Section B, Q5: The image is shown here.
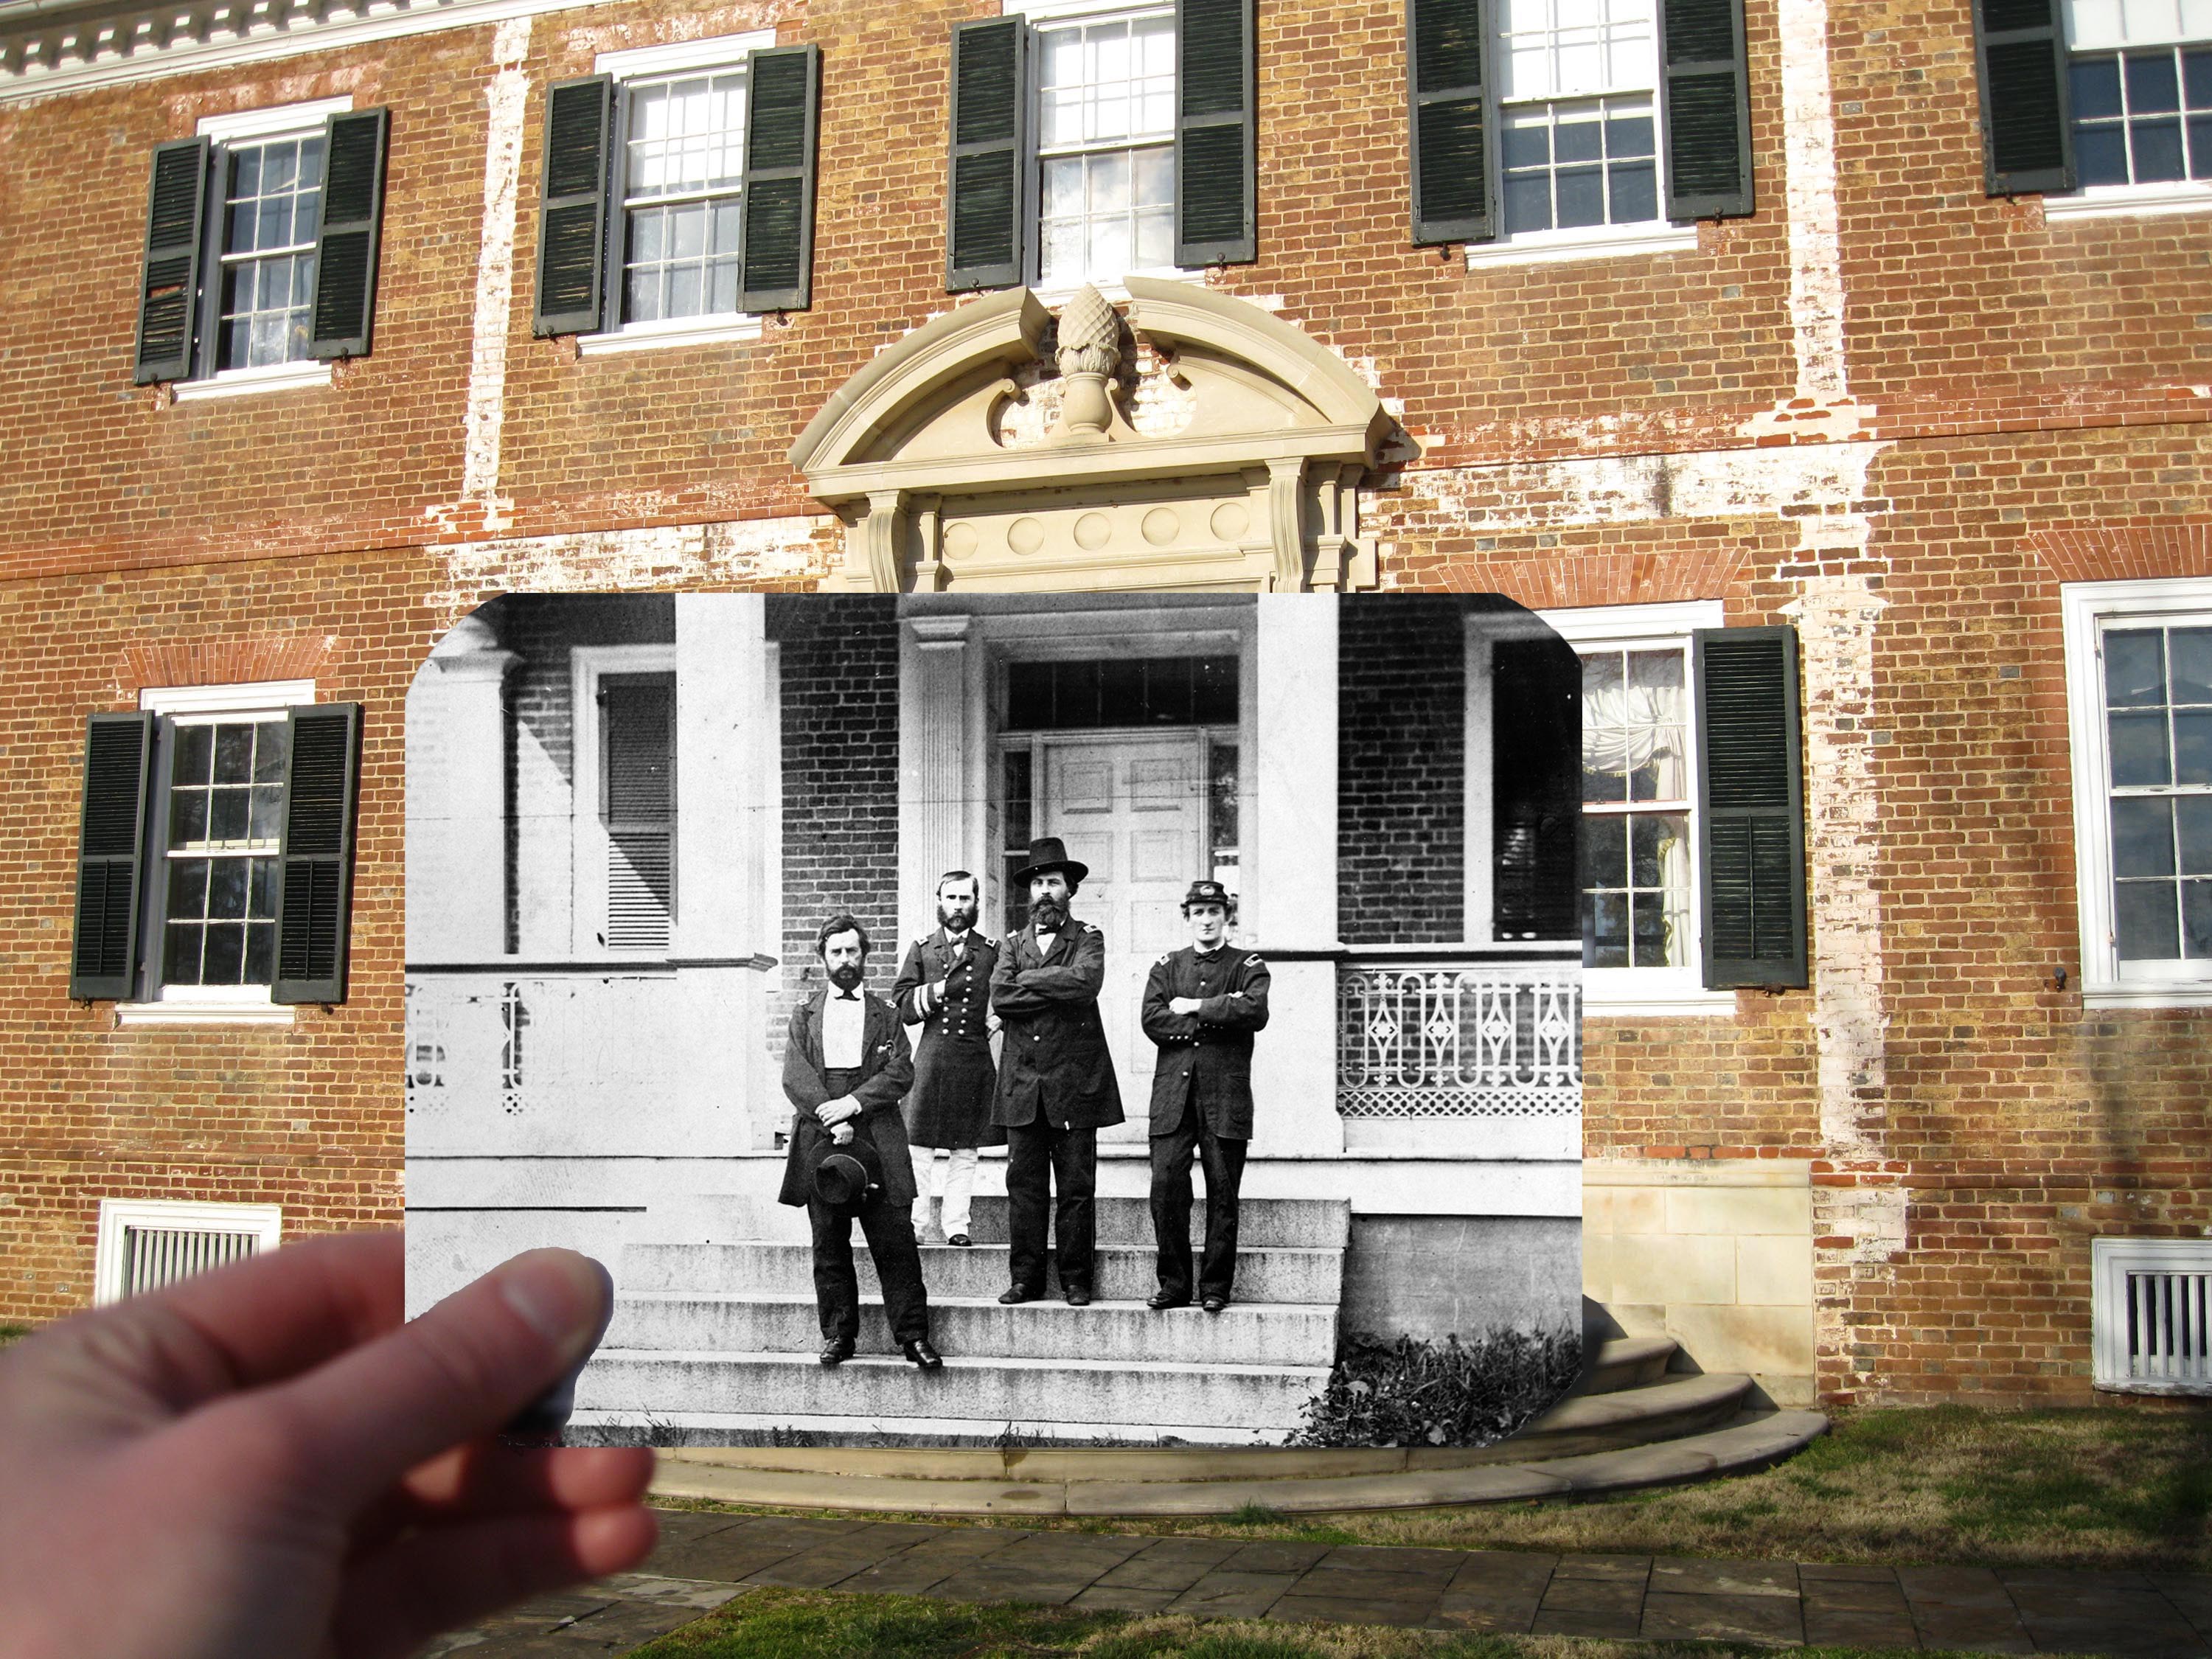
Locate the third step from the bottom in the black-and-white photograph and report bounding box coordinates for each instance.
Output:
[617,1239,1345,1307]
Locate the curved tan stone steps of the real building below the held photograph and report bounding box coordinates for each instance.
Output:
[653,1336,1827,1517]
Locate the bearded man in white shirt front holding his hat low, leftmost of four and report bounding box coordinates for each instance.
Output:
[776,914,945,1371]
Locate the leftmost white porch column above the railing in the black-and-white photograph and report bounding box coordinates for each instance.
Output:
[407,617,522,962]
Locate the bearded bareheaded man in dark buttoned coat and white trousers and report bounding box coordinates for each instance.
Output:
[891,869,1006,1245]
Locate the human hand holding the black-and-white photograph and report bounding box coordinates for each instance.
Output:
[0,1232,655,1659]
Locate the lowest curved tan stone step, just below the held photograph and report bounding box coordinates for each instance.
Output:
[653,1411,1827,1517]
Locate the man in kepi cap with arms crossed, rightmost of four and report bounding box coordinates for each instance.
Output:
[1144,880,1267,1314]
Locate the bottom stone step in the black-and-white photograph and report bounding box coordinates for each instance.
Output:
[575,1345,1329,1444]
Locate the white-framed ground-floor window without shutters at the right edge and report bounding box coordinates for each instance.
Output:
[2059,577,2212,1006]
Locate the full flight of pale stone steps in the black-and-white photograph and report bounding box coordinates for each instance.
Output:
[577,1197,1352,1447]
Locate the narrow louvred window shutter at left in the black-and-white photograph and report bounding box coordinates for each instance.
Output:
[599,675,677,951]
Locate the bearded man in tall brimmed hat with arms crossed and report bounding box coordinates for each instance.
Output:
[991,836,1121,1307]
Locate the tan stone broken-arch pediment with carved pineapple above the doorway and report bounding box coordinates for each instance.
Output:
[792,276,1391,593]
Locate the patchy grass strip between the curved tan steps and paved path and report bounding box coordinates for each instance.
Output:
[655,1407,2212,1573]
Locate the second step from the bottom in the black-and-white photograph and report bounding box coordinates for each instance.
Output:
[606,1290,1336,1367]
